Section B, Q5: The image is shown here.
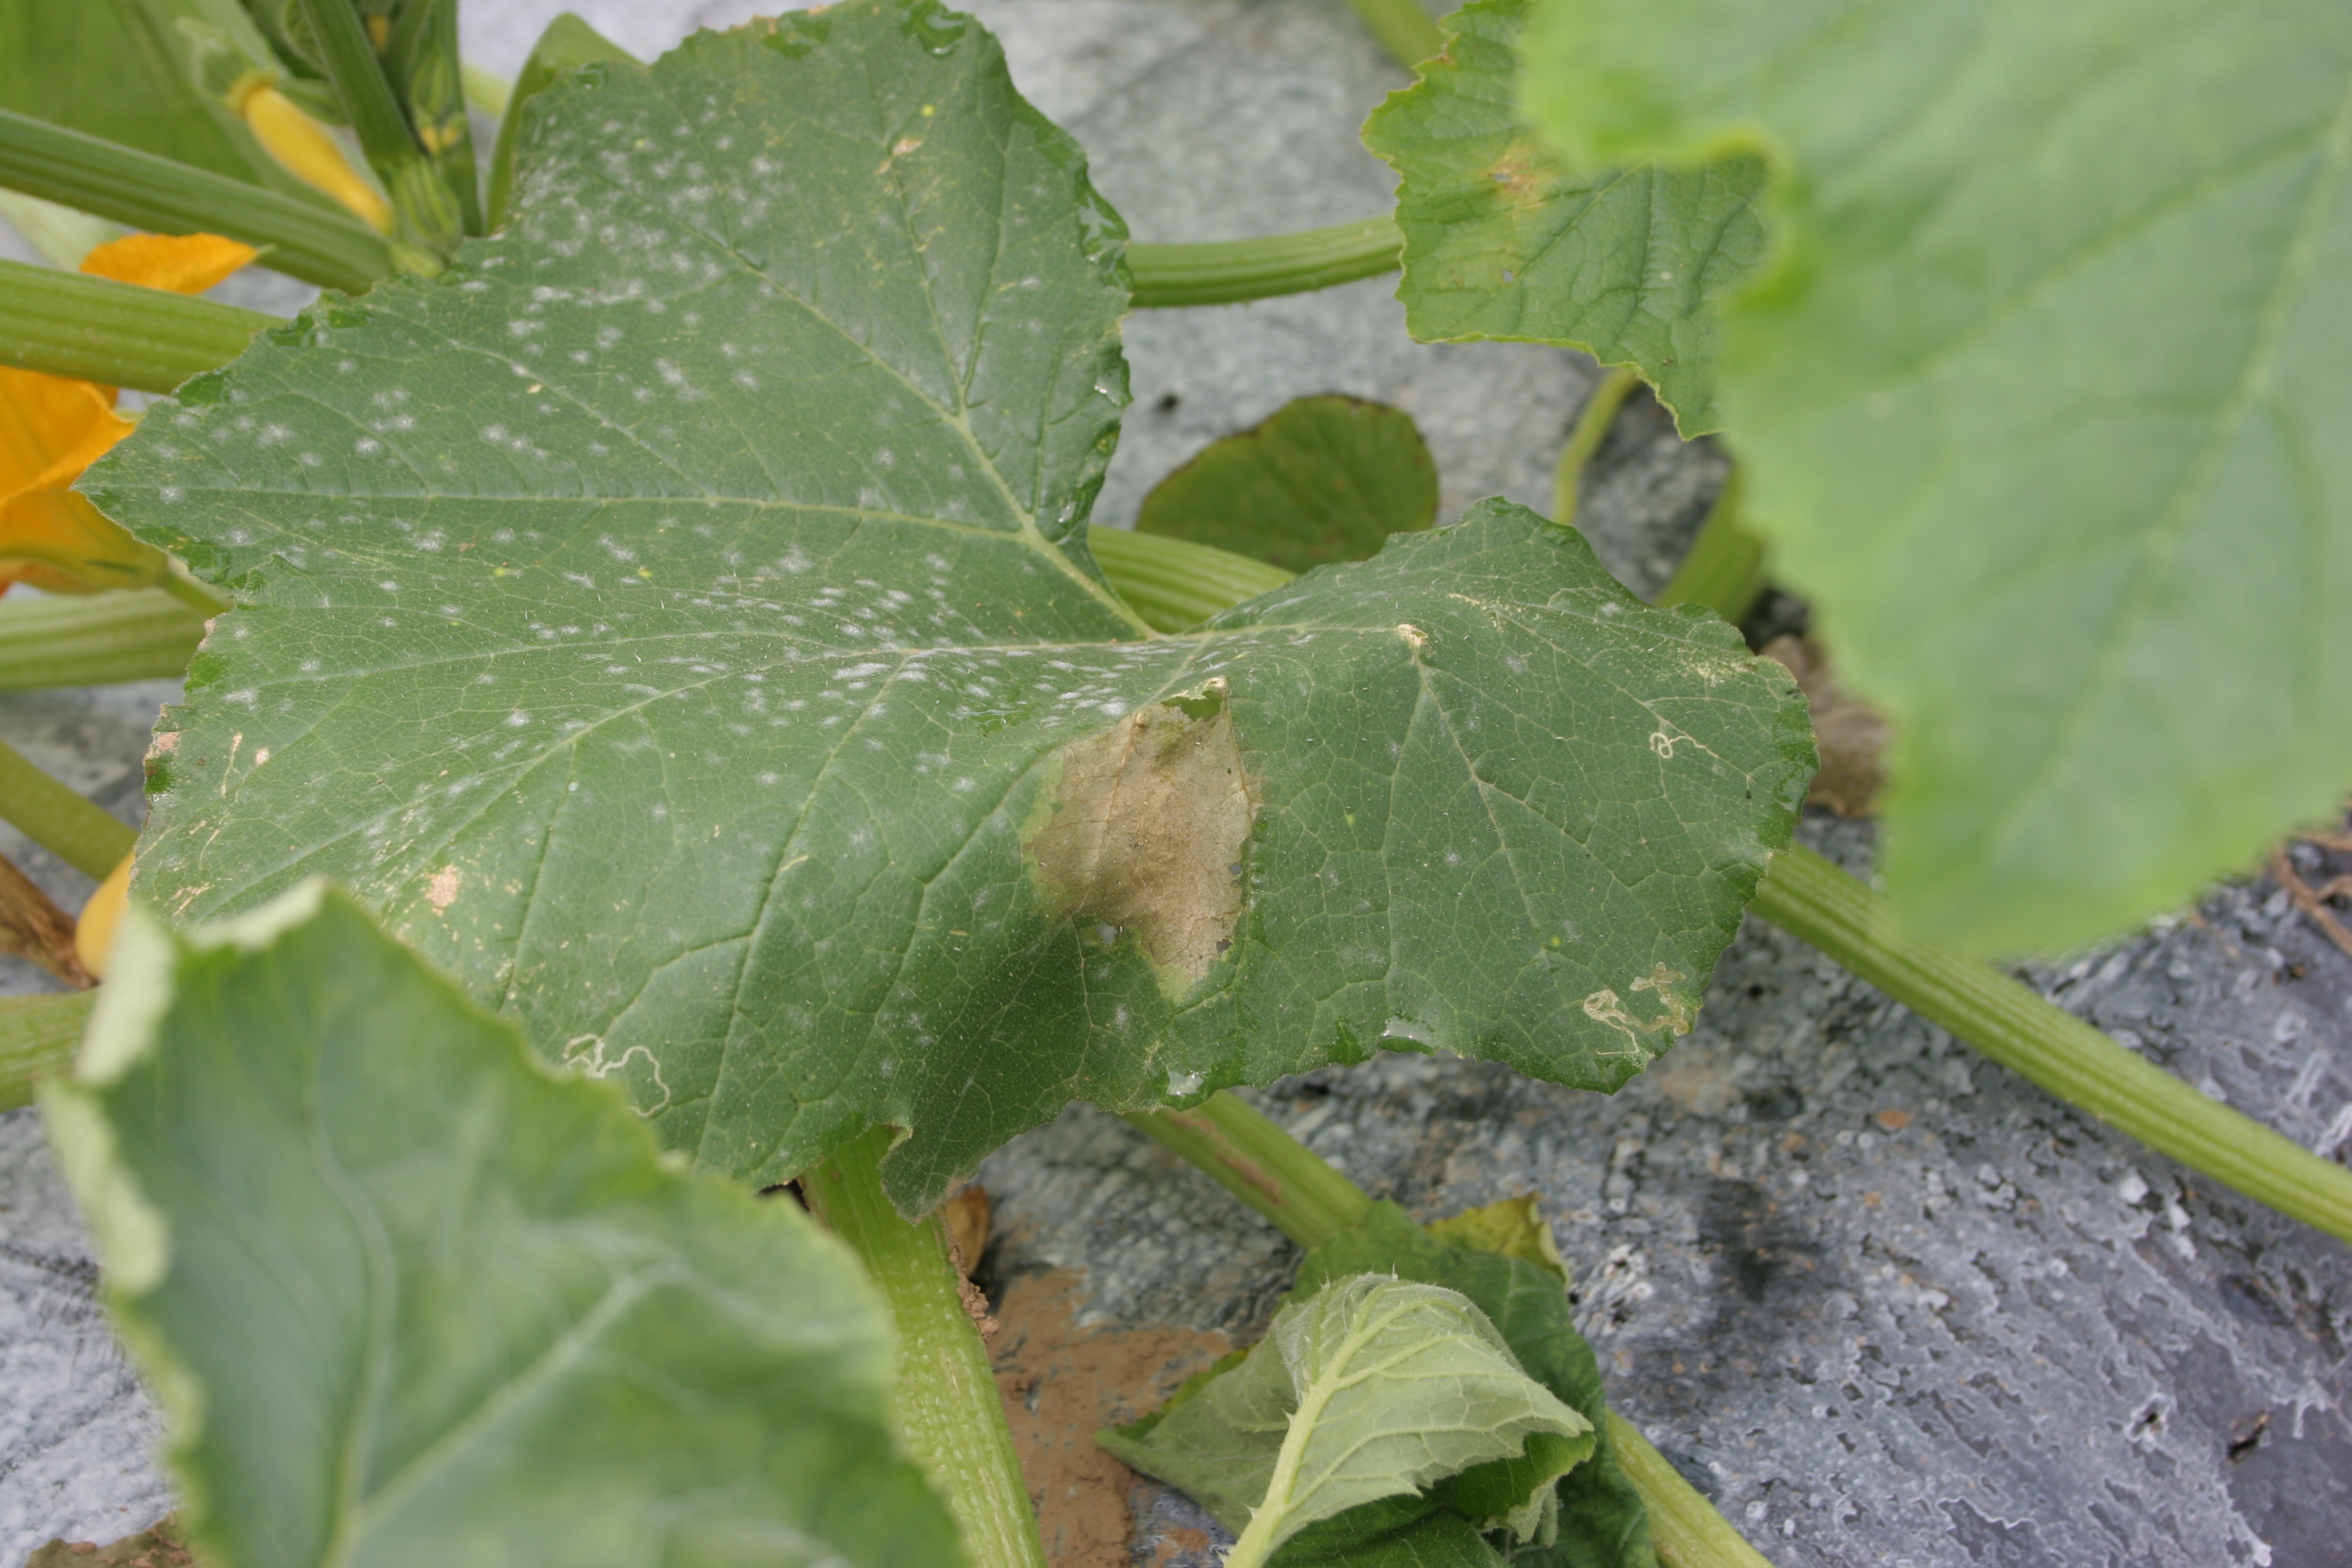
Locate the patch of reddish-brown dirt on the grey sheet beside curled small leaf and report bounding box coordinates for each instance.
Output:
[990,1269,1232,1568]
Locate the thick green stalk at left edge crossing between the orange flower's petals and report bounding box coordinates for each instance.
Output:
[0,261,285,393]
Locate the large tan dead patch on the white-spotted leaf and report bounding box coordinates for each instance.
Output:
[1028,680,1258,980]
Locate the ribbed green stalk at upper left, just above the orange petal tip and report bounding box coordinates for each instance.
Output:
[0,111,393,294]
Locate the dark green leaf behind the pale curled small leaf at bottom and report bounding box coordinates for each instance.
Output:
[1292,1199,1659,1568]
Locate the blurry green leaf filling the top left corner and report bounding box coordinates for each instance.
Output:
[0,0,341,212]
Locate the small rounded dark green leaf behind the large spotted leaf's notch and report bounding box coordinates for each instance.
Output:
[1136,393,1437,571]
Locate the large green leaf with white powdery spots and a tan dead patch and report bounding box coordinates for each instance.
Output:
[85,0,1813,1213]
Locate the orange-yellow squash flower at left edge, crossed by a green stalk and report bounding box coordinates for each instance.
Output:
[0,235,256,593]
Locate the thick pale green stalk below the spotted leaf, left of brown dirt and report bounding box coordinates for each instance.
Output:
[800,1126,1045,1568]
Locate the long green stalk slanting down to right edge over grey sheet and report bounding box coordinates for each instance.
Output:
[1747,846,2352,1242]
